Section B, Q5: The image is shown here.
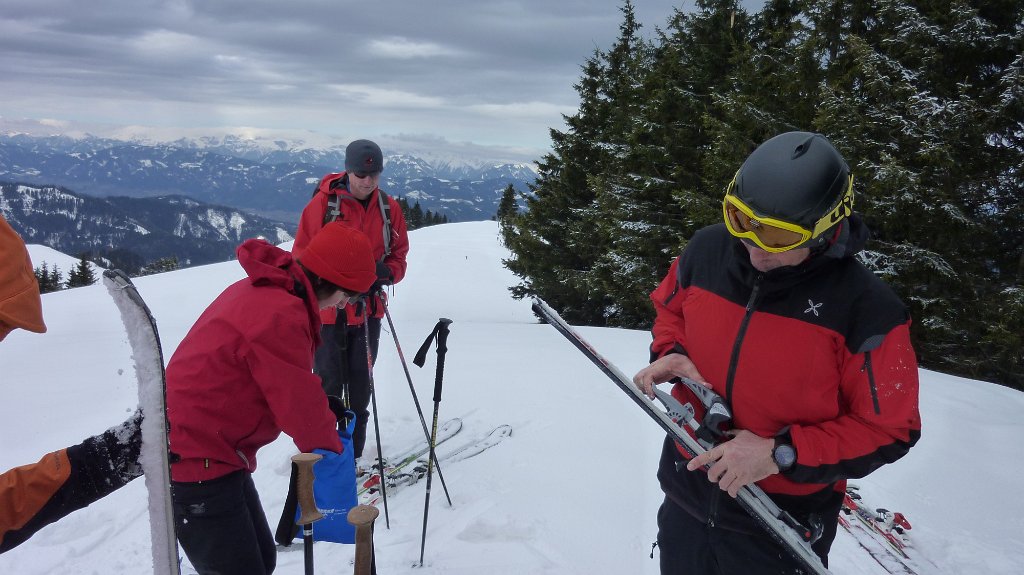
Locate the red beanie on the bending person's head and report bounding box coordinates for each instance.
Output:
[299,222,377,294]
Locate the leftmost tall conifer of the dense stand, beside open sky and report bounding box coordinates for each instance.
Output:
[503,0,646,324]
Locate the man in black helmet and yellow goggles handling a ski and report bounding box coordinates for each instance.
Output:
[634,132,921,575]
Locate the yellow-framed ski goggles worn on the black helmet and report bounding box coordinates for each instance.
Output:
[722,172,853,254]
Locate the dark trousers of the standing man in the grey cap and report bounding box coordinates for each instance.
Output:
[313,314,381,458]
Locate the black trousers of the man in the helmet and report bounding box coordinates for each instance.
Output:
[657,495,819,575]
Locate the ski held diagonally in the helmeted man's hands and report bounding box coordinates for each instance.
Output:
[532,298,830,575]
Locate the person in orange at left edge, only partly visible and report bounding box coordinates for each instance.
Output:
[0,216,142,554]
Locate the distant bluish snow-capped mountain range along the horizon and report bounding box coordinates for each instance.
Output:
[0,119,537,221]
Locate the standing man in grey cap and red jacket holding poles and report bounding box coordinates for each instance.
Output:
[292,140,409,458]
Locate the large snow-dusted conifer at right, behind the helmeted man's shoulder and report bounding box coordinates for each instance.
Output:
[811,1,1022,384]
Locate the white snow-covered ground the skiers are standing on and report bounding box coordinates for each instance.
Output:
[0,222,1024,575]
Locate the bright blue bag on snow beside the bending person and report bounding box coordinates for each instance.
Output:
[295,411,358,543]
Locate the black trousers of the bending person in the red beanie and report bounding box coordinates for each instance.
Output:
[171,471,278,575]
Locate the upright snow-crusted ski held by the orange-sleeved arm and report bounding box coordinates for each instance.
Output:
[103,270,180,575]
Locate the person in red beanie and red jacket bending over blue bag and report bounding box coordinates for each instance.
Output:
[167,223,377,575]
